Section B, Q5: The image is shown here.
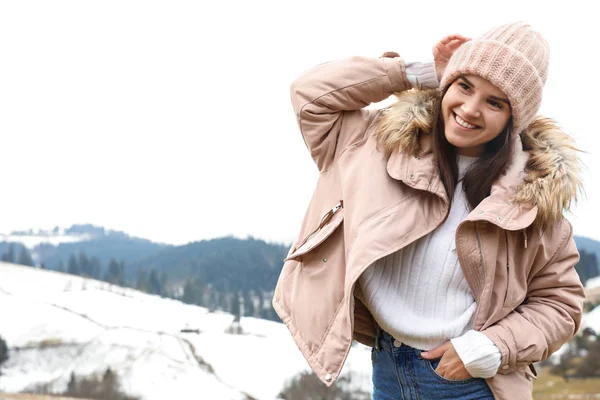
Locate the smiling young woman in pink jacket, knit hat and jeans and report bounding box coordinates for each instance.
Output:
[273,23,584,400]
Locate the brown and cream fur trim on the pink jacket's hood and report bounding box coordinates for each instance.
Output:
[377,90,582,227]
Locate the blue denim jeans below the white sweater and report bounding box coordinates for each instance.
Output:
[371,330,494,400]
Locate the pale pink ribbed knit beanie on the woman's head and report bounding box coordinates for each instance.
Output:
[440,22,549,134]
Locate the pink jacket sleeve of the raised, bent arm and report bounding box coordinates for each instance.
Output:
[291,53,411,172]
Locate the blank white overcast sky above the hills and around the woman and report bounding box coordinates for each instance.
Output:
[0,0,600,244]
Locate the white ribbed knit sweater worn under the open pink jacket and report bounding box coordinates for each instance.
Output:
[359,129,501,378]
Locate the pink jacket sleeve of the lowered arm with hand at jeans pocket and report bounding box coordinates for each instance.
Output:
[482,219,585,374]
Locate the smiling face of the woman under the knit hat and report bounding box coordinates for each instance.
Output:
[442,75,511,157]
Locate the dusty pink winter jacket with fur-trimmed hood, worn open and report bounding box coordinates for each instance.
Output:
[273,57,584,400]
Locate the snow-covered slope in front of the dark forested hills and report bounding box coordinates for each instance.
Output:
[0,263,371,400]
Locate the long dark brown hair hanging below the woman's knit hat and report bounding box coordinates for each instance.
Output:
[432,89,512,209]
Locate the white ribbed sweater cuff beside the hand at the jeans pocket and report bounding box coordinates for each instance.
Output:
[451,330,501,378]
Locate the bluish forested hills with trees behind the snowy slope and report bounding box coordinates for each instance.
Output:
[0,237,600,321]
